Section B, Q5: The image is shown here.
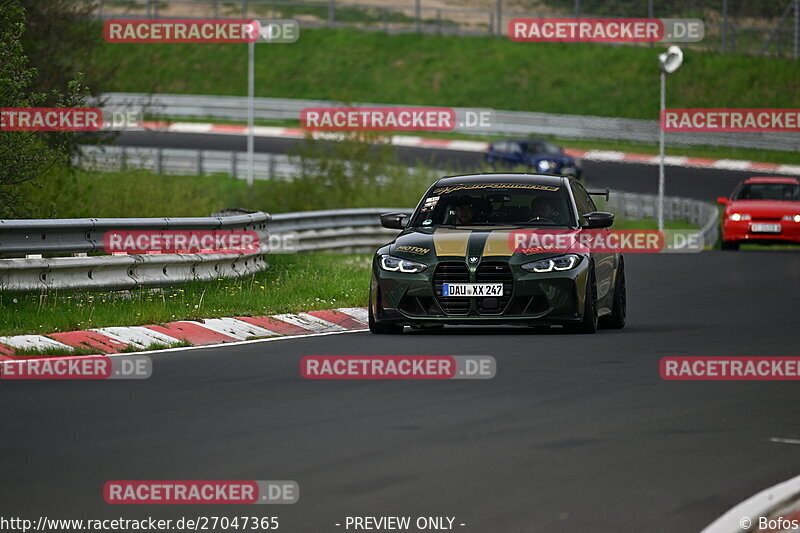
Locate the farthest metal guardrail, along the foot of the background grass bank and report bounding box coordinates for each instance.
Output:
[99,93,800,151]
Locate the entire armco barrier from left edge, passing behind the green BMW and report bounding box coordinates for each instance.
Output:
[0,197,719,290]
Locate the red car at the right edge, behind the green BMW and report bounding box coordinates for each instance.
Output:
[717,178,800,250]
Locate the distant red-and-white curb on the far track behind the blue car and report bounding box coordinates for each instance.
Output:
[140,122,800,176]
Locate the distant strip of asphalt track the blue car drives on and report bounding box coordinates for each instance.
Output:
[116,131,768,201]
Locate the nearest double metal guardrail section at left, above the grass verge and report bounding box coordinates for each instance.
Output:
[0,213,270,290]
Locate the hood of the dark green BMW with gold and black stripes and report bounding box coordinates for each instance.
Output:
[382,226,574,263]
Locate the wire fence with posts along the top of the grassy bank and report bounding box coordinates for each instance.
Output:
[97,0,800,60]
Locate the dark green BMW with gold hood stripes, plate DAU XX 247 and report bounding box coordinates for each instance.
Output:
[369,174,625,334]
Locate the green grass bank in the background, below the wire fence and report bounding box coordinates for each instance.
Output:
[96,29,800,119]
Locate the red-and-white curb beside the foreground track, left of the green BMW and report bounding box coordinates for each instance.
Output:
[0,307,368,361]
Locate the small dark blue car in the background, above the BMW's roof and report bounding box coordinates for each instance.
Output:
[486,139,583,179]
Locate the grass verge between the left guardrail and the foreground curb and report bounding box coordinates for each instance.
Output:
[0,254,371,336]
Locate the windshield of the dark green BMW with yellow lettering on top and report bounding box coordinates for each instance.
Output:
[411,183,575,227]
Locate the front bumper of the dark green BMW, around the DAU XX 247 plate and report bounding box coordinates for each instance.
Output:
[370,258,589,326]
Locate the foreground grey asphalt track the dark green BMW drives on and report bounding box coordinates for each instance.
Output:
[0,252,800,533]
